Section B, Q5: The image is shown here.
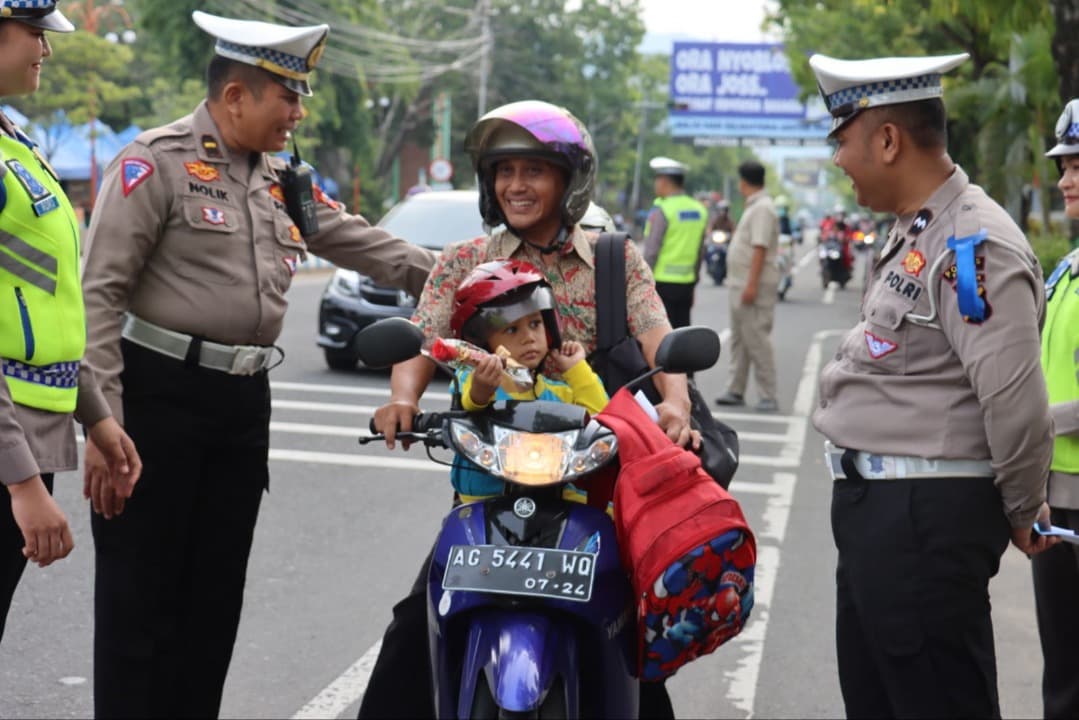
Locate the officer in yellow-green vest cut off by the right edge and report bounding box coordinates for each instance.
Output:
[1030,99,1079,718]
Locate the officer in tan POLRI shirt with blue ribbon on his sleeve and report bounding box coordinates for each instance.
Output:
[809,54,1052,718]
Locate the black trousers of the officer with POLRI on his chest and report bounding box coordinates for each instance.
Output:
[832,472,1011,718]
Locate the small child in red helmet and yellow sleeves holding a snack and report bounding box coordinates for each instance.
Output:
[450,260,609,502]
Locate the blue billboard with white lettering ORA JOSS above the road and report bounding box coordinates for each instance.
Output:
[668,42,831,142]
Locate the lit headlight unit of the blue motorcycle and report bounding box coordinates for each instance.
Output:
[450,422,617,486]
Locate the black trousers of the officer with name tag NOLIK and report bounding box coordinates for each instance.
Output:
[92,341,270,718]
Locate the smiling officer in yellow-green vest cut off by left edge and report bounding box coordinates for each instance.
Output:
[0,0,142,639]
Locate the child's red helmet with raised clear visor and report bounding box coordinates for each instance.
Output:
[450,260,562,350]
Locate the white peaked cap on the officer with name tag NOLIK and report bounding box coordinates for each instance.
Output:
[191,10,330,96]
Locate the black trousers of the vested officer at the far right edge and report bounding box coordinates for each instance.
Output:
[1030,507,1079,719]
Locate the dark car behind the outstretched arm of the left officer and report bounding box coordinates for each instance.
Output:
[318,190,484,370]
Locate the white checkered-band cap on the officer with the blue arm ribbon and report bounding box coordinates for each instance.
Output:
[809,53,970,137]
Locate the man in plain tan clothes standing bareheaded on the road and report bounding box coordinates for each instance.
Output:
[715,160,779,412]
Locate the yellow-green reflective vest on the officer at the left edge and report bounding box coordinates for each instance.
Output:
[0,133,86,412]
